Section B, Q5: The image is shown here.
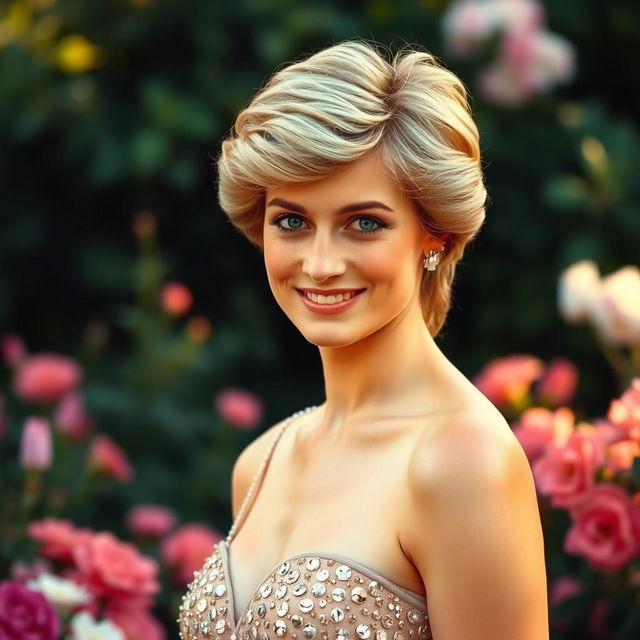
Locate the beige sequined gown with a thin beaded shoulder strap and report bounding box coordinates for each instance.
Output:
[178,411,432,640]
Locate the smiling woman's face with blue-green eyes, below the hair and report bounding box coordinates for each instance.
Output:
[263,155,442,347]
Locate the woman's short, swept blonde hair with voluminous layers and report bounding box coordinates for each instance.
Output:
[218,41,487,336]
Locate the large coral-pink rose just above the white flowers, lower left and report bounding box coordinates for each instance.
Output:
[73,532,159,598]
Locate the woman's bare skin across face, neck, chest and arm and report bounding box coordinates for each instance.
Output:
[230,155,548,640]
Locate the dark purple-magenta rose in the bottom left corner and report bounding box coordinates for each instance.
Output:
[0,582,60,640]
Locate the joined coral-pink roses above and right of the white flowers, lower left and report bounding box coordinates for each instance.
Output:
[28,518,165,640]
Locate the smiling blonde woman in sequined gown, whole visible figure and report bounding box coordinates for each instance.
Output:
[179,41,548,640]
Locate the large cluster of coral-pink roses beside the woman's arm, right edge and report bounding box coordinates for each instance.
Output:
[513,378,640,571]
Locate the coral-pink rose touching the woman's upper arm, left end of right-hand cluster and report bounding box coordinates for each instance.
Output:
[512,407,574,464]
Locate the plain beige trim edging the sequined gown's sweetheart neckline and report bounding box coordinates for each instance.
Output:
[217,539,427,633]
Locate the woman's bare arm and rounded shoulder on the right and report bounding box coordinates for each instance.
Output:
[409,411,549,640]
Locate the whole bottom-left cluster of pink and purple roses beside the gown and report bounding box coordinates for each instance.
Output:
[5,504,222,640]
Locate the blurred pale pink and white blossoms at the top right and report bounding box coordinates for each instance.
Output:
[443,0,575,106]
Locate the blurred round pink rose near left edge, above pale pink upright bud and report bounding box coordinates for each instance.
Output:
[13,353,82,403]
